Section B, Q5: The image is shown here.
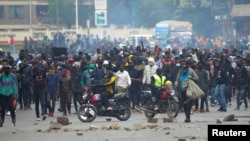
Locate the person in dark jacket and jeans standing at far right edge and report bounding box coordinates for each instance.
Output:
[233,57,249,110]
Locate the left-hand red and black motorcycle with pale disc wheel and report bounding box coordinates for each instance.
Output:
[78,88,131,122]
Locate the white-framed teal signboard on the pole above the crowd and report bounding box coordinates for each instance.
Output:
[95,10,107,26]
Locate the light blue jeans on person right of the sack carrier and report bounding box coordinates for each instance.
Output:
[214,84,227,110]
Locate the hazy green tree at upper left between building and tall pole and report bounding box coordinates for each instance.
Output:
[47,0,75,28]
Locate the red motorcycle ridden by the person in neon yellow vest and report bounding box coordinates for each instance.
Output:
[141,88,179,119]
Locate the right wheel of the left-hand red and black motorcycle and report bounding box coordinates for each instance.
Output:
[116,102,131,121]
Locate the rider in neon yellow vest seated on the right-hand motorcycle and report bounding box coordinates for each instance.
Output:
[151,68,175,110]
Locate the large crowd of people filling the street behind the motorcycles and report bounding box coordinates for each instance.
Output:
[0,33,250,126]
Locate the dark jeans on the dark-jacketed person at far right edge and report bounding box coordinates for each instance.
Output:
[235,85,248,109]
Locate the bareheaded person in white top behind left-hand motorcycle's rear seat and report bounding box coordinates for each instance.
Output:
[115,64,131,93]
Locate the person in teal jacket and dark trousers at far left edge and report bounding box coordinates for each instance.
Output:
[0,60,18,127]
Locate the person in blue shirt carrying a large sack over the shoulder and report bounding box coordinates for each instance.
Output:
[175,60,198,123]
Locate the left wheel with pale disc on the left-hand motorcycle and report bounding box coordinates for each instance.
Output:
[78,105,97,122]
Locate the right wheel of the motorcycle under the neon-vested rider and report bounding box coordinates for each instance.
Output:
[167,100,179,118]
